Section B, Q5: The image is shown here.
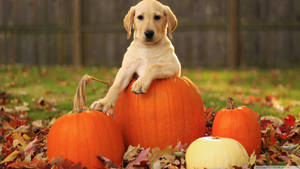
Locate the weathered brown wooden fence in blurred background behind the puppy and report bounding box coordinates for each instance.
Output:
[0,0,300,68]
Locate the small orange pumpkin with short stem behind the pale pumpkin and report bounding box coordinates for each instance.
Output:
[212,97,261,155]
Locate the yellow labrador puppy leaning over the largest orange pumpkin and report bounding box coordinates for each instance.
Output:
[90,0,181,114]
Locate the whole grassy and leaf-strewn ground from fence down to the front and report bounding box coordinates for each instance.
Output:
[0,66,300,169]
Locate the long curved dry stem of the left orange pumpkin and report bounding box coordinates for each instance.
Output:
[73,74,110,112]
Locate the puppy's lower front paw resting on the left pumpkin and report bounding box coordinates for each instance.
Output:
[90,99,114,115]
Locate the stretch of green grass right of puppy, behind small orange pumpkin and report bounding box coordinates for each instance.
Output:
[184,69,300,118]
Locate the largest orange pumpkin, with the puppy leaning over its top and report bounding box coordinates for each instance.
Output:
[115,77,206,148]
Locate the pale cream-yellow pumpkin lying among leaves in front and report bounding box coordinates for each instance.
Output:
[185,137,249,169]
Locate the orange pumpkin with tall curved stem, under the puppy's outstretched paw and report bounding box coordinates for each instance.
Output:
[47,75,124,169]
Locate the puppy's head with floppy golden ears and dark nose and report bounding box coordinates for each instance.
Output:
[124,0,177,44]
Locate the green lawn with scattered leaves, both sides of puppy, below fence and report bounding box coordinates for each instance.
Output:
[0,66,300,119]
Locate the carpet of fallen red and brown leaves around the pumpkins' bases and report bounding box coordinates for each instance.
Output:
[0,102,300,169]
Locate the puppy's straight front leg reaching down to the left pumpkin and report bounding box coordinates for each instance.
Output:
[90,68,134,114]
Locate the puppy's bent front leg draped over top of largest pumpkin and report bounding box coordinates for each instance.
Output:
[131,64,180,94]
